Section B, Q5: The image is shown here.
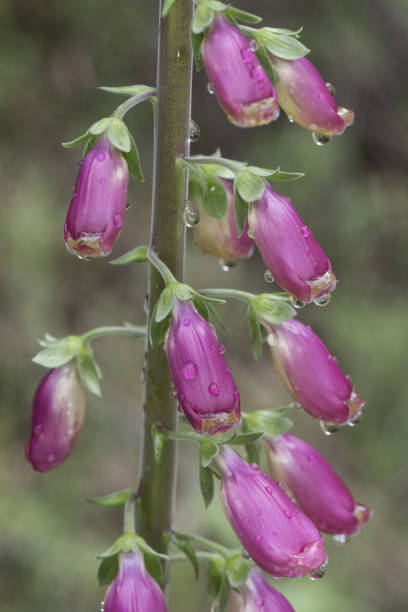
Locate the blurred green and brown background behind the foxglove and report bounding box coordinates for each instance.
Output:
[0,0,408,612]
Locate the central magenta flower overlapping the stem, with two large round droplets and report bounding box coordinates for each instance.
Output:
[166,300,241,434]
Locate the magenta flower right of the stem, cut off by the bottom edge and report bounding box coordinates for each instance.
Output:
[230,568,295,612]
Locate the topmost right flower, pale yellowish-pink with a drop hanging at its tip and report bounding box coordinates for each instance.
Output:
[270,55,354,135]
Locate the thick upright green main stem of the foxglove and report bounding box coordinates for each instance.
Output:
[138,0,193,580]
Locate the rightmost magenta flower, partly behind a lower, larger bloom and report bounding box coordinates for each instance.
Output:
[264,434,371,536]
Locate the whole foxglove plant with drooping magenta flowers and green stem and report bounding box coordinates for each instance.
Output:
[26,0,370,612]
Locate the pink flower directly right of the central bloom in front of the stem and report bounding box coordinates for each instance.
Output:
[269,319,365,425]
